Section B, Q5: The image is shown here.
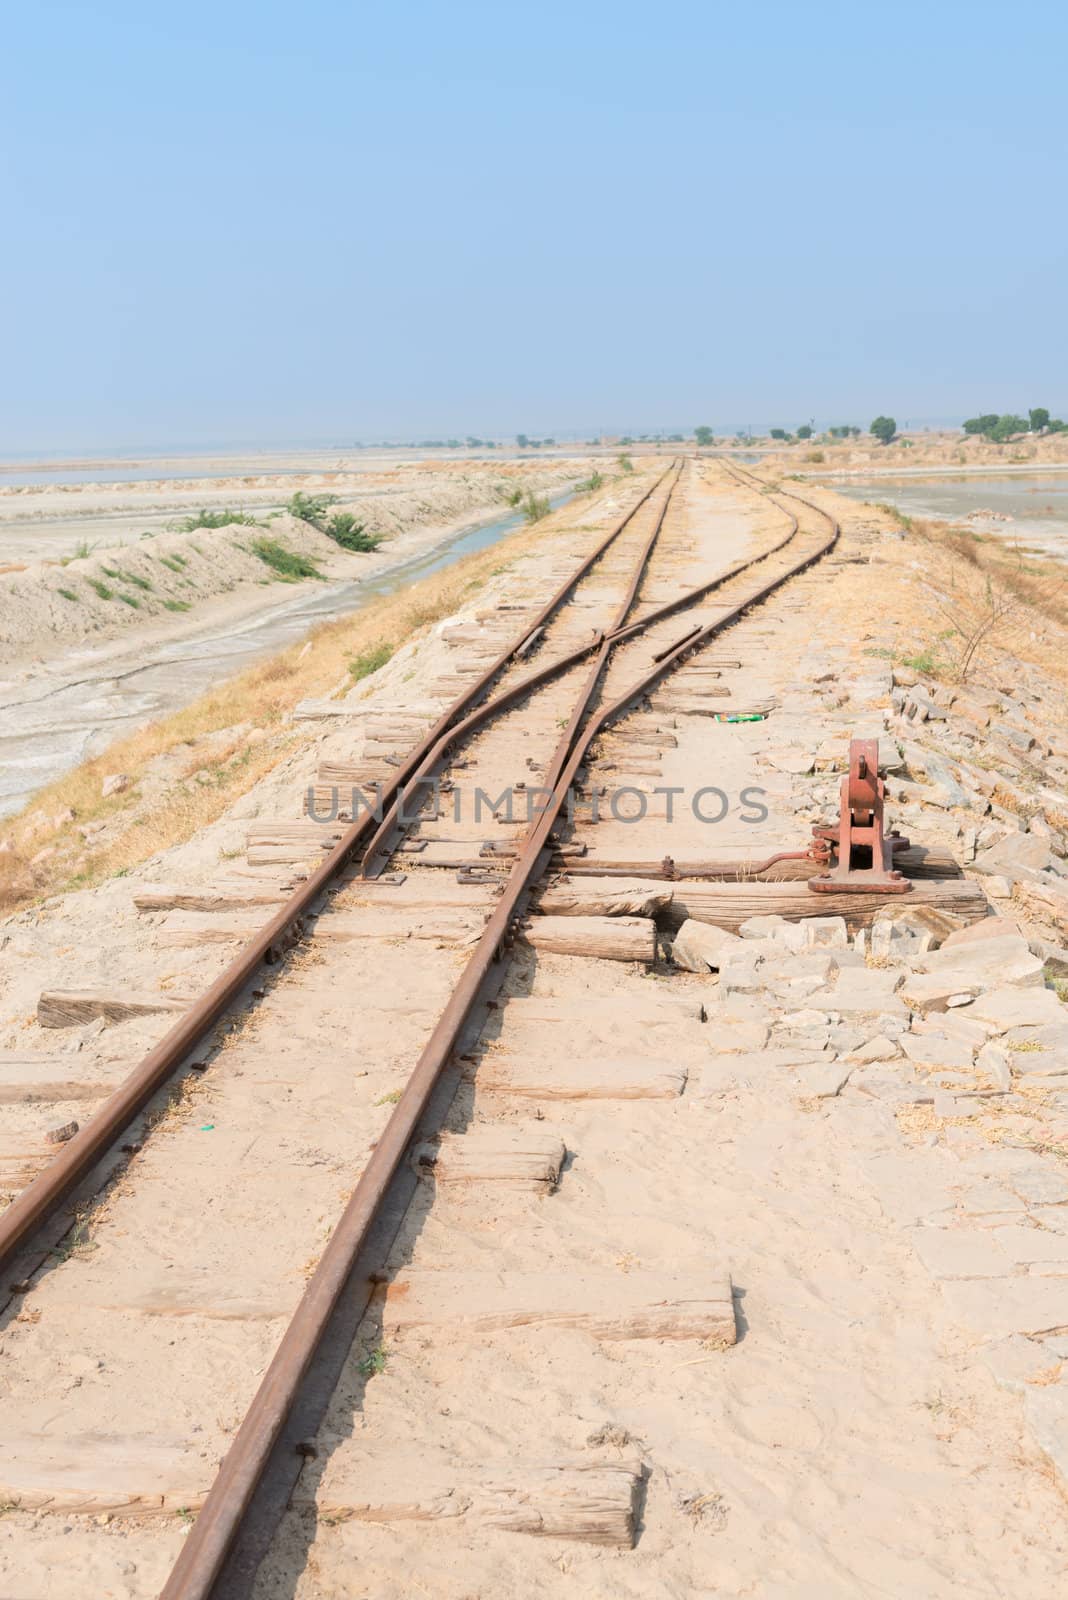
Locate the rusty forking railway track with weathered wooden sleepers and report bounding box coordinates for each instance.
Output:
[0,462,856,1600]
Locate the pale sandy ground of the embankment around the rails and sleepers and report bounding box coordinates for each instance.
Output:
[0,464,1068,1600]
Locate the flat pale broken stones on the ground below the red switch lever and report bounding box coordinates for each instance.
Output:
[687,907,1068,1478]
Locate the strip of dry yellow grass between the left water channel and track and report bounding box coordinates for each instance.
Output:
[0,483,620,914]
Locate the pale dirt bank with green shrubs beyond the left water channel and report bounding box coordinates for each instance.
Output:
[0,461,585,670]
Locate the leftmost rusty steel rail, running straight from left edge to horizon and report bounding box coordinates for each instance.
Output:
[0,462,676,1269]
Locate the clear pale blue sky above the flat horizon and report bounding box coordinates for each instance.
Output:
[0,0,1068,454]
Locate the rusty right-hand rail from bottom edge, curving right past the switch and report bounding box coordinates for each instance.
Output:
[160,467,839,1600]
